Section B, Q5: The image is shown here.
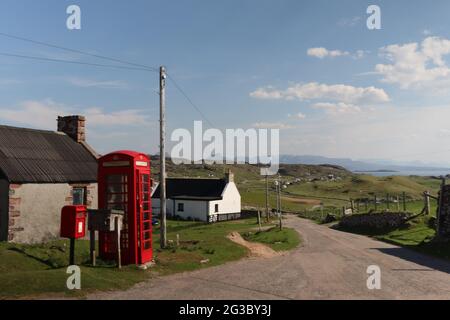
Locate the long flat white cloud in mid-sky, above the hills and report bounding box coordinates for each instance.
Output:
[250,82,389,104]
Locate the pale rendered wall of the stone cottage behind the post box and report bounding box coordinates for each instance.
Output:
[8,183,98,243]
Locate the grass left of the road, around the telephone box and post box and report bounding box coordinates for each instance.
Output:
[0,219,295,298]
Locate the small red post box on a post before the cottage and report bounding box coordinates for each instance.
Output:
[61,206,87,239]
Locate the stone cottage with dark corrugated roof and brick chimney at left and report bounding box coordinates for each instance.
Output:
[0,116,97,243]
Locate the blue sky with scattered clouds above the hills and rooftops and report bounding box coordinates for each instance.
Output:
[0,0,450,165]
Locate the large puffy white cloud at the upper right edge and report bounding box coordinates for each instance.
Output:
[375,37,450,89]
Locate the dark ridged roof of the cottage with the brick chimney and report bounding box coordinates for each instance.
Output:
[0,126,97,183]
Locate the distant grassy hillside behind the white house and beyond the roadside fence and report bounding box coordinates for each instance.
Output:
[152,159,440,211]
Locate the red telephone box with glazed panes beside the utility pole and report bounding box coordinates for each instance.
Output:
[98,151,153,265]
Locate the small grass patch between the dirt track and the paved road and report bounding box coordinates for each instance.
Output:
[242,227,300,251]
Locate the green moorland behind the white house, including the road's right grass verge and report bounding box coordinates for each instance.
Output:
[153,161,450,259]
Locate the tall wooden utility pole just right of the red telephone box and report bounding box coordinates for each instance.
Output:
[159,67,167,249]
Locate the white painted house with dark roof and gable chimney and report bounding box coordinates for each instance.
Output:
[152,171,241,223]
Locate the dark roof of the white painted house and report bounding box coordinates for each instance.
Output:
[153,178,227,200]
